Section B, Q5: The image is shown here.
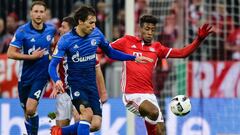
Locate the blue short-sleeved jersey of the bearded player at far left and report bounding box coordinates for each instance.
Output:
[10,22,56,84]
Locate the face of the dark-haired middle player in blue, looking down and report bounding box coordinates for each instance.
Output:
[79,15,96,35]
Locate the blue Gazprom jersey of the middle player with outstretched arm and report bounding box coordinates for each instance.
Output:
[50,28,135,89]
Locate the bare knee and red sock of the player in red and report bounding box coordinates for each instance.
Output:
[139,100,165,135]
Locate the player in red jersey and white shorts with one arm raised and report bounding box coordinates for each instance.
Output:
[111,15,213,135]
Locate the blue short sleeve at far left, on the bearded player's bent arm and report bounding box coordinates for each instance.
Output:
[10,28,24,48]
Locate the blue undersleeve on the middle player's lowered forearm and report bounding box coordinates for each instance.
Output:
[48,57,61,83]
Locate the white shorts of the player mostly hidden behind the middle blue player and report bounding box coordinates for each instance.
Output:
[56,93,73,120]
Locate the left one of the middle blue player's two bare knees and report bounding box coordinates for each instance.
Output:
[80,105,93,122]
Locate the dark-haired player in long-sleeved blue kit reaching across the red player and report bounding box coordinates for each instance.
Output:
[49,6,152,135]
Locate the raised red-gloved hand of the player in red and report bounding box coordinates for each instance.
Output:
[198,24,214,40]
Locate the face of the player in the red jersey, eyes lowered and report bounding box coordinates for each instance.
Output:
[140,23,156,43]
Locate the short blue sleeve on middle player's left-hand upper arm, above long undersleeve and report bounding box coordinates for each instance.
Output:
[53,37,67,58]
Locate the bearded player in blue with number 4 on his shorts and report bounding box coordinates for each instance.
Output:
[7,1,56,135]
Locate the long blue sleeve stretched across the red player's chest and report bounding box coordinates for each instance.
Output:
[99,35,136,61]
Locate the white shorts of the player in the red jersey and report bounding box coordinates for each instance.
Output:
[122,93,163,124]
